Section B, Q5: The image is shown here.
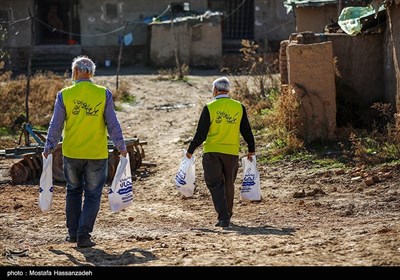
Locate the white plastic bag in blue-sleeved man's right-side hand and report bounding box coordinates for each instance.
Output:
[108,153,133,212]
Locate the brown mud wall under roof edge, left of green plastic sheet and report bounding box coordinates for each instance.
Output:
[295,5,339,33]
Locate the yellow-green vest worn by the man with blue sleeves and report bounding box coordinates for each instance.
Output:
[62,81,108,159]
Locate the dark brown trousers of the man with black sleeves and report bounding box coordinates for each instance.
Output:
[202,153,239,220]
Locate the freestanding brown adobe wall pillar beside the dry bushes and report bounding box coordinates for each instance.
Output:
[287,41,336,142]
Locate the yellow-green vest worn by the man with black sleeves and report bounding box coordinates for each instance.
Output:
[203,98,243,156]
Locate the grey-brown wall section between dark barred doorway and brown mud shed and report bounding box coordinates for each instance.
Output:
[254,0,295,46]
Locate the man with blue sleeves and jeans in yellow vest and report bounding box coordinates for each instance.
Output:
[43,56,127,247]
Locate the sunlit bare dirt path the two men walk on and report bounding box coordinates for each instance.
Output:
[0,70,400,266]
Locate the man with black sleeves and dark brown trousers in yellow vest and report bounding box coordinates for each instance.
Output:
[186,77,255,227]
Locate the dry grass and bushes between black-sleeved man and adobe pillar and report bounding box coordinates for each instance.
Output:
[224,40,304,156]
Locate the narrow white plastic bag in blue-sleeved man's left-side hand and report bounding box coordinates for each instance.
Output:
[39,153,54,212]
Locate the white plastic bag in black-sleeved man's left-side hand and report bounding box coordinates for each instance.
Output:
[175,149,196,197]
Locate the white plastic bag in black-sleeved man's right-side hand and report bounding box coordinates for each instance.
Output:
[240,156,261,201]
